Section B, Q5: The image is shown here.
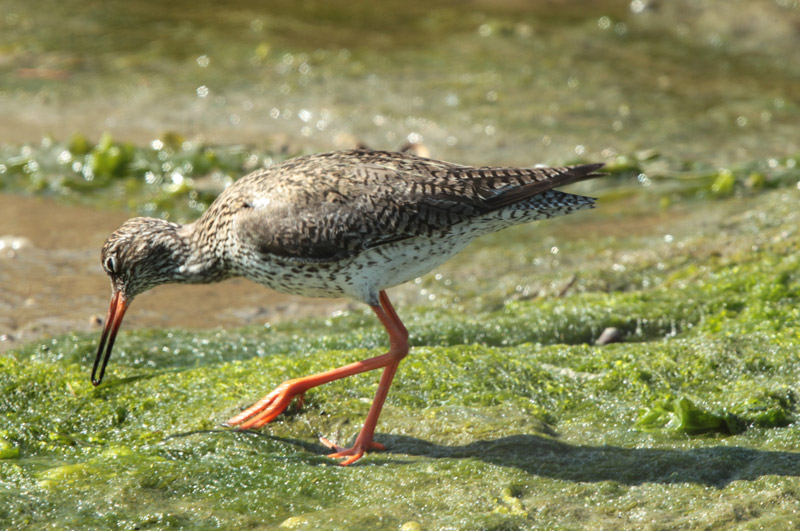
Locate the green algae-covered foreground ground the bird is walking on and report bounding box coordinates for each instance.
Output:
[0,140,800,530]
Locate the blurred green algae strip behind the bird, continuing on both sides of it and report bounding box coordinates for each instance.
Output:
[0,132,800,228]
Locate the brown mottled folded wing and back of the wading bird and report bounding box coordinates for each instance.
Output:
[231,151,602,261]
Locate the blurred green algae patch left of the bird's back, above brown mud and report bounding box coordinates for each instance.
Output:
[0,132,294,221]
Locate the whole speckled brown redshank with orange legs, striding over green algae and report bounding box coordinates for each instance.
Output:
[92,149,602,465]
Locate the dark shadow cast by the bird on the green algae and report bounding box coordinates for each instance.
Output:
[240,432,800,487]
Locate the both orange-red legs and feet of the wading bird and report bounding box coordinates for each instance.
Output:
[226,291,408,465]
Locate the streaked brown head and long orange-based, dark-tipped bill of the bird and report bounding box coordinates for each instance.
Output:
[92,218,188,385]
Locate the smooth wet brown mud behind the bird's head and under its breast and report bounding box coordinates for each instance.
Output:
[0,195,346,351]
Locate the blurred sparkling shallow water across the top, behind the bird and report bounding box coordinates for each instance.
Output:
[0,0,800,166]
